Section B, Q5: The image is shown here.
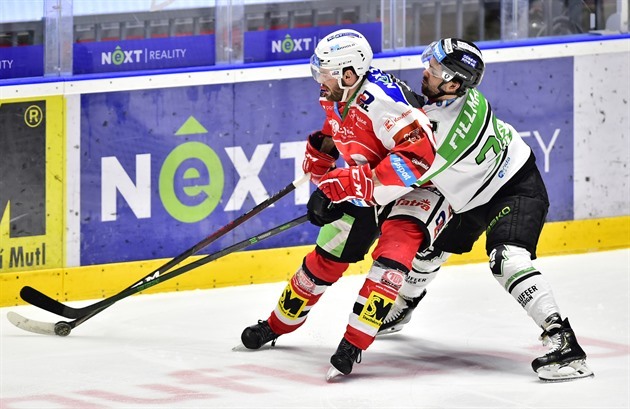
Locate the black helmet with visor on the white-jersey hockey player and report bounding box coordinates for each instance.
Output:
[422,38,485,95]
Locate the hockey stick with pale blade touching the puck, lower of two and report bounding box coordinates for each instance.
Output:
[7,215,307,337]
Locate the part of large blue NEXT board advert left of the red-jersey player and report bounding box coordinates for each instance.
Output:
[81,79,321,265]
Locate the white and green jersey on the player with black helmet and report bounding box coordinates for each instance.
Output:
[416,89,531,213]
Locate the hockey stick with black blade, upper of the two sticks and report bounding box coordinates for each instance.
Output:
[20,173,310,318]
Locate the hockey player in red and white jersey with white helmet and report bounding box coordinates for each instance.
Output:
[241,30,450,379]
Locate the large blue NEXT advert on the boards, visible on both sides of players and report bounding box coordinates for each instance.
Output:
[80,58,573,265]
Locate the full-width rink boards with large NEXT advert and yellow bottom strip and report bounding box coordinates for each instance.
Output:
[0,32,630,305]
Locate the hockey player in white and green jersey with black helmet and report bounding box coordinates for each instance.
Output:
[379,38,593,381]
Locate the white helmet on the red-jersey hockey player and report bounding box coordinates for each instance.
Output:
[311,29,373,88]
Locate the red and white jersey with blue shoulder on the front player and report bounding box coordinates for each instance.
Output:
[320,68,436,204]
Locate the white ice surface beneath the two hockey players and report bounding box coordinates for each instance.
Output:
[0,249,630,409]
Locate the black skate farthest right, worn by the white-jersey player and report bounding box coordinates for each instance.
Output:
[532,314,593,382]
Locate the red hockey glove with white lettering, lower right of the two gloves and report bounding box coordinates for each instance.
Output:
[318,164,374,204]
